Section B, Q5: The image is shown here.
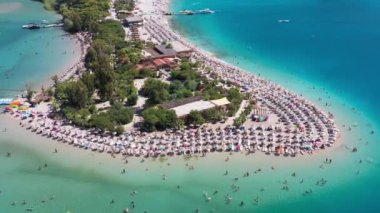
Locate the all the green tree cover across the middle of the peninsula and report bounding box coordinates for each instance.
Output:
[45,0,243,134]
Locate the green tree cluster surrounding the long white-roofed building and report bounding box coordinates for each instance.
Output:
[141,60,243,131]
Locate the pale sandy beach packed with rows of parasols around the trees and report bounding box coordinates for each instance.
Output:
[0,1,339,161]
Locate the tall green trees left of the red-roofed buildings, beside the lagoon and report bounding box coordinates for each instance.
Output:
[44,0,144,133]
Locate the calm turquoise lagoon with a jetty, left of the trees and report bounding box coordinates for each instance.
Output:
[0,0,79,97]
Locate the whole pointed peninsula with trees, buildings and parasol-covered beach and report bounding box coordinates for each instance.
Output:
[5,0,339,157]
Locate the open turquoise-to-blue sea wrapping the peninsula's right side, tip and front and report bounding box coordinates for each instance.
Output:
[0,0,380,213]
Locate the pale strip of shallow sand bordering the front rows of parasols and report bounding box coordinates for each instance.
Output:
[0,114,354,177]
